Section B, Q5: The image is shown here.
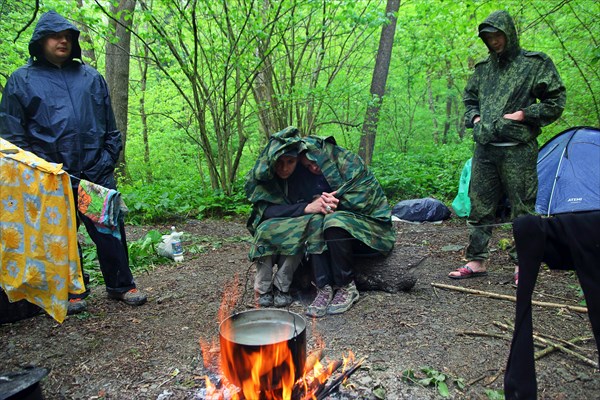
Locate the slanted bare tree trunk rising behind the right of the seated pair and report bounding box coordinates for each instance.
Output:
[358,0,400,165]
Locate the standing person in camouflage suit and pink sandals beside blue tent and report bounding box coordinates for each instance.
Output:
[449,11,566,282]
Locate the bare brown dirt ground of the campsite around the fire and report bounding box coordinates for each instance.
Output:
[0,220,600,400]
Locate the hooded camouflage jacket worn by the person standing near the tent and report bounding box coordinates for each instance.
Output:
[463,11,566,144]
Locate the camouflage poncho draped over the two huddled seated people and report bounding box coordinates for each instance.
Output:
[245,127,395,260]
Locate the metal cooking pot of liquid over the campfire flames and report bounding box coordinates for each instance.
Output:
[219,309,306,390]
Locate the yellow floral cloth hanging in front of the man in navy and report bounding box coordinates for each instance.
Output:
[0,138,84,322]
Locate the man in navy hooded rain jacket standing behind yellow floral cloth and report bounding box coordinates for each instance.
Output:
[0,11,146,313]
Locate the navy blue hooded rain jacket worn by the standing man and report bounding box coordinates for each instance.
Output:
[0,11,123,189]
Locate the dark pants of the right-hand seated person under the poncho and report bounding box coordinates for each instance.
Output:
[311,228,375,288]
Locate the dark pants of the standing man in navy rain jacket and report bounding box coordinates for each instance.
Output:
[69,192,135,298]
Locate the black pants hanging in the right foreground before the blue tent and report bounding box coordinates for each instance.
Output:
[504,211,600,400]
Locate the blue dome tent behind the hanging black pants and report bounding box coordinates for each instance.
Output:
[535,126,600,215]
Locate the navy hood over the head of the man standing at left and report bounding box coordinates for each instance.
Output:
[29,11,81,60]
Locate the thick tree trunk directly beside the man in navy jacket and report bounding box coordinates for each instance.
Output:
[106,0,136,180]
